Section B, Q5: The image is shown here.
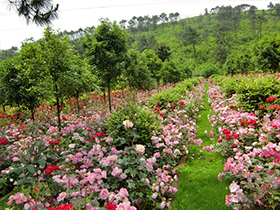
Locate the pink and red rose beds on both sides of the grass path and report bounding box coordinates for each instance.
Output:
[0,73,280,210]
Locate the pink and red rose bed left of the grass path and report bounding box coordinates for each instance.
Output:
[0,78,204,210]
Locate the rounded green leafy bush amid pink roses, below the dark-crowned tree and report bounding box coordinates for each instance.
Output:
[107,102,160,155]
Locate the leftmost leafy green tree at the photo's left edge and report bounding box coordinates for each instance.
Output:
[1,40,47,120]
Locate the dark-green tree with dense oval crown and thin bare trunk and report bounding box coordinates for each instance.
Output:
[84,20,127,111]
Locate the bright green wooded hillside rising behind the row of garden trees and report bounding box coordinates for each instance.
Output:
[0,2,280,78]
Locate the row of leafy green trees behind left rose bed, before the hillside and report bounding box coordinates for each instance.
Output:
[0,19,191,127]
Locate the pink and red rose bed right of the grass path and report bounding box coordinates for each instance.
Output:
[208,76,280,209]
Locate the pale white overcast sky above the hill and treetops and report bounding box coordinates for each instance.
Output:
[0,0,280,49]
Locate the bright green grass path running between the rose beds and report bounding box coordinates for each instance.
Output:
[173,84,229,210]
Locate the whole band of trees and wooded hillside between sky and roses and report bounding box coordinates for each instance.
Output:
[0,3,280,124]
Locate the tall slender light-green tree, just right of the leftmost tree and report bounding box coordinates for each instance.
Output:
[39,27,80,129]
